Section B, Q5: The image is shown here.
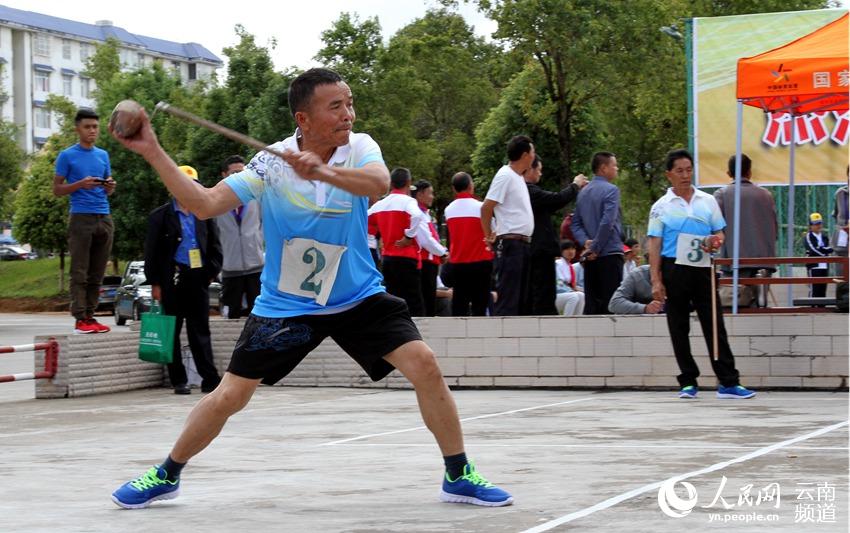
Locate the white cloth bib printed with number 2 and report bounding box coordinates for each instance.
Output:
[277,238,346,305]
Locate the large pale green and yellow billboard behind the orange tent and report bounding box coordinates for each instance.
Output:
[689,9,850,186]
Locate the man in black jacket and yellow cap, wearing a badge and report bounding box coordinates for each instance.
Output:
[145,166,222,394]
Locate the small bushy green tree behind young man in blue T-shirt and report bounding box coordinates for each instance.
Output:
[13,95,77,286]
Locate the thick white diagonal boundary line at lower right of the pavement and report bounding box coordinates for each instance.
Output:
[522,420,850,533]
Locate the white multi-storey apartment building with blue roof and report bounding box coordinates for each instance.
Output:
[0,5,223,152]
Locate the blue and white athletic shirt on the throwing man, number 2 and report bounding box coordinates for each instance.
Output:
[224,131,384,318]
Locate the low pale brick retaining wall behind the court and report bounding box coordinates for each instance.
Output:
[35,314,848,398]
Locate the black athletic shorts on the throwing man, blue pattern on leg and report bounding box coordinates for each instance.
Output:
[227,292,422,385]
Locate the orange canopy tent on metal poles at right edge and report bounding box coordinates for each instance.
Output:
[732,14,850,313]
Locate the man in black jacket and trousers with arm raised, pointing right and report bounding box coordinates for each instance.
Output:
[523,157,587,315]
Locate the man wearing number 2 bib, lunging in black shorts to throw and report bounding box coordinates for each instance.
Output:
[112,69,513,509]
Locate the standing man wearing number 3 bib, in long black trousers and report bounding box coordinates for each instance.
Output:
[647,150,755,399]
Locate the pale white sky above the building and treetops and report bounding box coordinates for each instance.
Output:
[6,0,496,69]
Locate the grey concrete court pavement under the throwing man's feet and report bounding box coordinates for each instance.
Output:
[0,387,848,533]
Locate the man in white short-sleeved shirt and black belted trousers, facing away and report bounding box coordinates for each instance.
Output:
[481,135,535,316]
